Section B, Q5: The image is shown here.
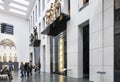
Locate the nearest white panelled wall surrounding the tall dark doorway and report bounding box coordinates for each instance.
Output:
[67,0,114,82]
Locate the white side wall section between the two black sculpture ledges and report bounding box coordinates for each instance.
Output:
[29,0,50,73]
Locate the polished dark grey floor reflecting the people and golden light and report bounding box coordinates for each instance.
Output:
[0,71,91,82]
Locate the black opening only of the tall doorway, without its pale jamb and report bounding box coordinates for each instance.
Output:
[83,25,89,79]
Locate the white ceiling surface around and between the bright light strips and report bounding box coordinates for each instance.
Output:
[0,0,35,19]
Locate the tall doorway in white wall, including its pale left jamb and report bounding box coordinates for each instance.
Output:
[78,20,89,80]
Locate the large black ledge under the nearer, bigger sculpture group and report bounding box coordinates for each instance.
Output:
[41,13,70,36]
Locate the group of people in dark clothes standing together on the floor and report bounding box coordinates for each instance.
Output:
[20,61,41,77]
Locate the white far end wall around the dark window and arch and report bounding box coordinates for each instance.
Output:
[0,13,29,62]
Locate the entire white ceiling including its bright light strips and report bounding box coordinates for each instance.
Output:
[0,0,35,19]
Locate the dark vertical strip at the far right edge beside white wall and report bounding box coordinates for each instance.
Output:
[114,0,120,82]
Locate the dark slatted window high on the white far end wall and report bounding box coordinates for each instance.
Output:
[1,23,14,35]
